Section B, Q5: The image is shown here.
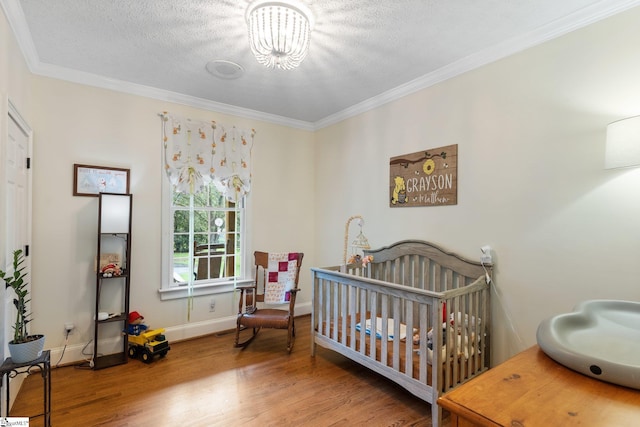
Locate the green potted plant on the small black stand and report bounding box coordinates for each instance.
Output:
[0,249,44,363]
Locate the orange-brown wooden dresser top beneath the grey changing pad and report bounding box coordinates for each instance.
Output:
[438,346,640,427]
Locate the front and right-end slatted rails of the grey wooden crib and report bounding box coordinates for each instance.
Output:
[311,268,488,384]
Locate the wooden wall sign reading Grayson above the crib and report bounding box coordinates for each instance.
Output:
[389,144,458,208]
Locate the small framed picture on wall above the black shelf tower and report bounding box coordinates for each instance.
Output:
[73,164,129,197]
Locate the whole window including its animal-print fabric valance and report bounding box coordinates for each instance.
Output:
[160,112,255,300]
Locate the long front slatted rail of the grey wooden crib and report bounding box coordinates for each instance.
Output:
[311,269,442,401]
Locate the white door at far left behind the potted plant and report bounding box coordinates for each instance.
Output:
[0,105,31,360]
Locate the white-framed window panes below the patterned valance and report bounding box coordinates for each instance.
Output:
[161,179,250,299]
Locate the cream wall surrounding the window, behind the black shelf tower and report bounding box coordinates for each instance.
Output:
[31,76,314,363]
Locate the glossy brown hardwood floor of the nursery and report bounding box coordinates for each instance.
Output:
[11,316,449,427]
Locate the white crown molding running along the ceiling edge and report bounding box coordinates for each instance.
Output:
[5,0,640,131]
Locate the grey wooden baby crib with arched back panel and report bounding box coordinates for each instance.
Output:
[311,240,491,427]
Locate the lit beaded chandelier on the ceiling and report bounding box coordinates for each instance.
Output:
[246,0,313,70]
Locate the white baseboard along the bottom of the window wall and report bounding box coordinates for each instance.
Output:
[47,302,311,368]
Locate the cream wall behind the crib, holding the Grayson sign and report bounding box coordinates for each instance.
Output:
[316,8,640,363]
